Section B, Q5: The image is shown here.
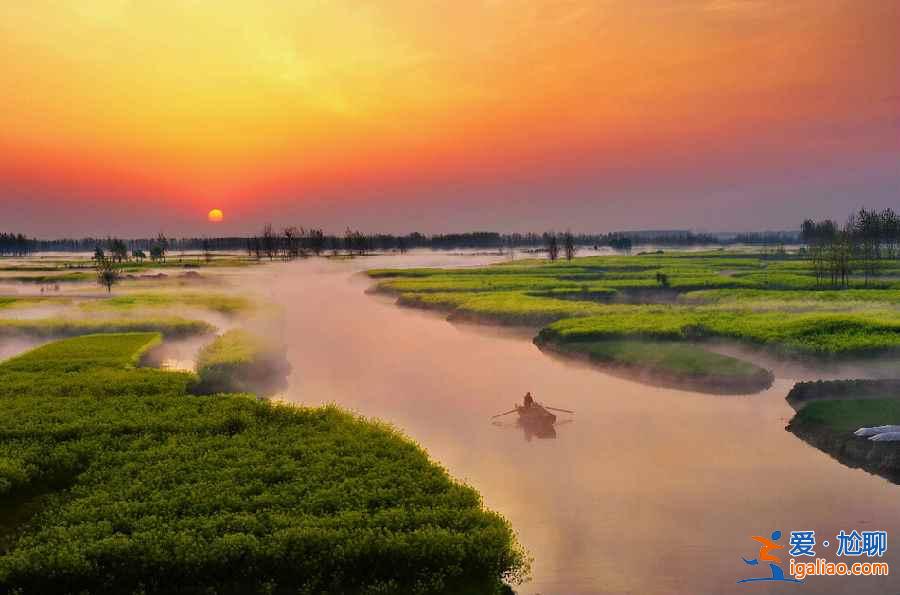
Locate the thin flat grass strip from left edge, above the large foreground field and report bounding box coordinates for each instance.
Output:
[0,316,214,338]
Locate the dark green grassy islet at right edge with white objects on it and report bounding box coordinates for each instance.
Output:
[787,396,900,483]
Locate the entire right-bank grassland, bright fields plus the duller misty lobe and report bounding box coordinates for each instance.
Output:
[369,251,900,392]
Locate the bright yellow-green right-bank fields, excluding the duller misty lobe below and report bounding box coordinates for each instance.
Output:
[378,251,900,356]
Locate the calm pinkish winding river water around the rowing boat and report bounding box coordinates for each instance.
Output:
[243,254,900,595]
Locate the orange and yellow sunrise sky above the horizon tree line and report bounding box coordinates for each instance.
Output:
[0,0,900,237]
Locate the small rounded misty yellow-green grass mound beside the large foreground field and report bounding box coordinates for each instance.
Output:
[195,329,290,394]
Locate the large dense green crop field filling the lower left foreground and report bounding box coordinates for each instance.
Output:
[0,333,525,593]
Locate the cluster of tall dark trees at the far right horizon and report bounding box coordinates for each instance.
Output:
[800,207,900,288]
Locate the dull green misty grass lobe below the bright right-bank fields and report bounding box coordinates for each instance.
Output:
[536,340,773,393]
